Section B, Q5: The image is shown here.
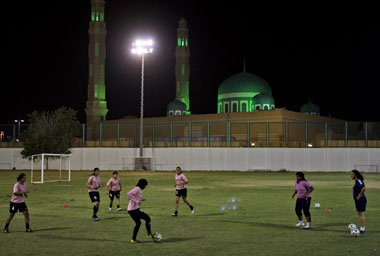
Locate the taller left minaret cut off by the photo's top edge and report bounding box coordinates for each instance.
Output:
[85,0,108,124]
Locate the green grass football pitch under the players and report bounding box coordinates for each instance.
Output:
[0,171,380,256]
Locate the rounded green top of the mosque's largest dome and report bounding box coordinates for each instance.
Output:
[218,72,272,95]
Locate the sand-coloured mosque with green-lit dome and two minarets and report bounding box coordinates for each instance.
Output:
[85,0,345,146]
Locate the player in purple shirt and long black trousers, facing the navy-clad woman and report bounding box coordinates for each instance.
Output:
[292,172,314,229]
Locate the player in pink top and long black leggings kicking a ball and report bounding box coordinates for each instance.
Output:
[128,179,155,244]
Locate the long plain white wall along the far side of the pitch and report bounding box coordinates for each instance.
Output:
[0,148,380,172]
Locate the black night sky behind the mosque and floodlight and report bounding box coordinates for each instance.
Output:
[0,0,380,124]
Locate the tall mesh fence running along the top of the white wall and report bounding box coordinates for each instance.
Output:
[0,121,380,148]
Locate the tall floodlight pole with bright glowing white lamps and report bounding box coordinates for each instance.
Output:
[131,40,153,169]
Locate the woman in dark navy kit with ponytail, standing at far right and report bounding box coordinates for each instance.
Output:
[351,170,367,233]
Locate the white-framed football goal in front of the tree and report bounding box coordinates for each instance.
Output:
[30,153,71,184]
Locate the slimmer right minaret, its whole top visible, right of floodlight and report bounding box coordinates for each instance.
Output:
[175,18,190,114]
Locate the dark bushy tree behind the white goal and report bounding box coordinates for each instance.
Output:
[21,107,80,158]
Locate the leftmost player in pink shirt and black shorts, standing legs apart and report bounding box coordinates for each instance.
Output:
[4,173,33,233]
